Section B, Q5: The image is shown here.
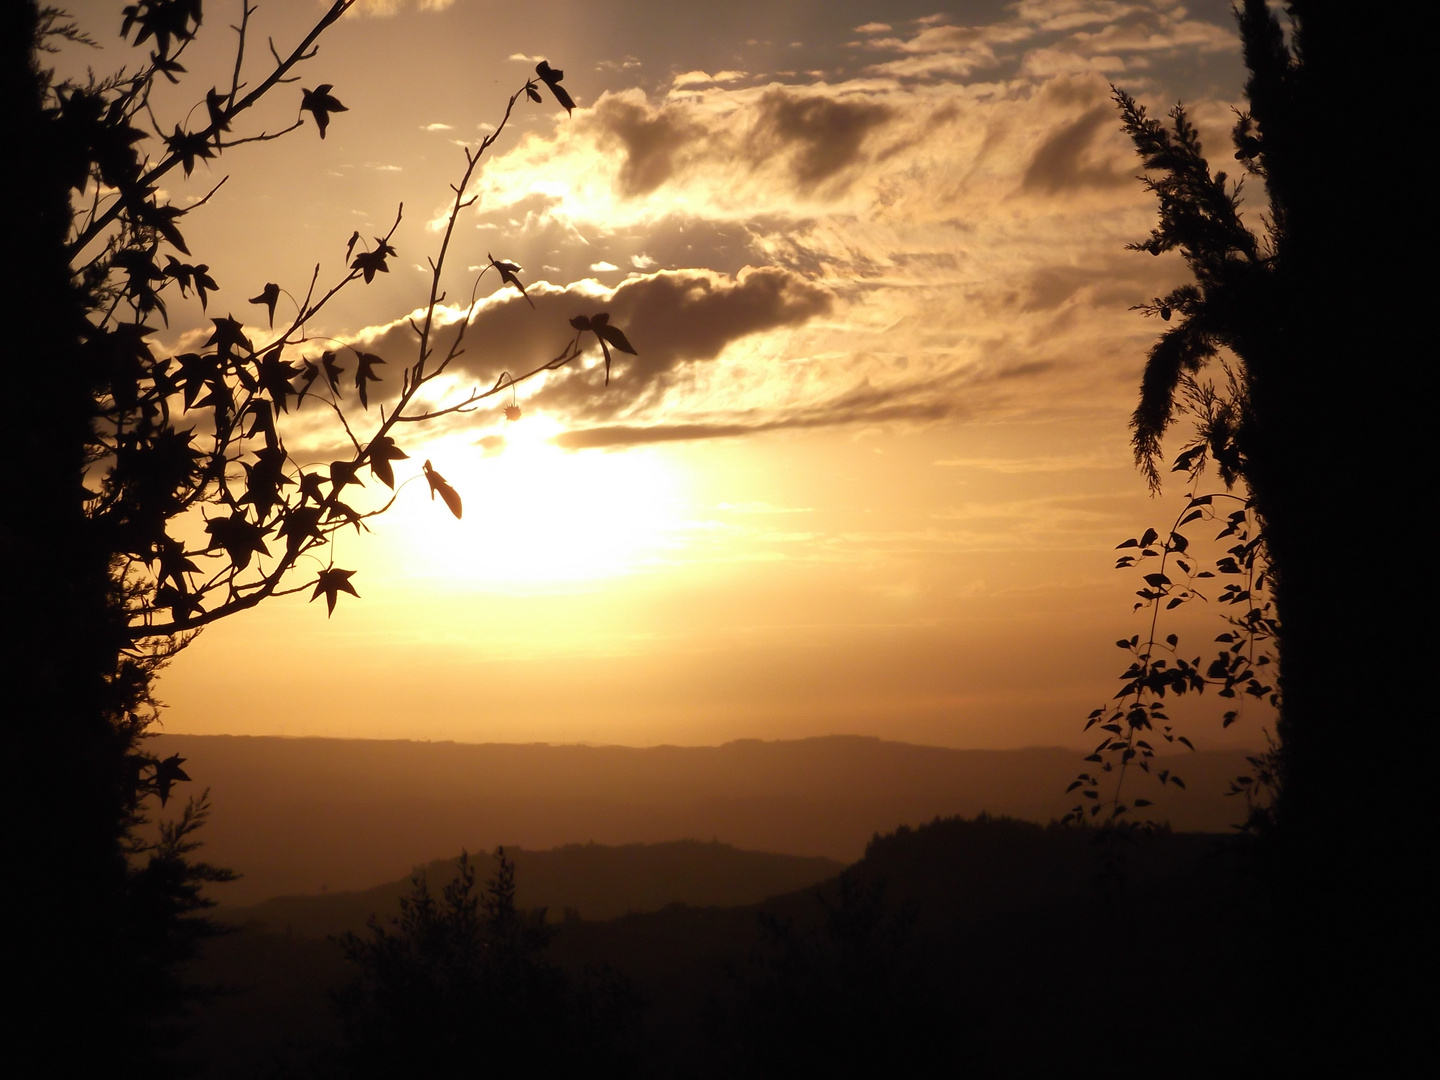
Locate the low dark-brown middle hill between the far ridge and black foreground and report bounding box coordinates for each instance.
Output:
[225,840,844,937]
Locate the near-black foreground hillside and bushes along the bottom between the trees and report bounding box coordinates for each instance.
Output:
[177,816,1284,1077]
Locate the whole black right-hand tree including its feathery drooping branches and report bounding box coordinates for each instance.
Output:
[1116,0,1427,1070]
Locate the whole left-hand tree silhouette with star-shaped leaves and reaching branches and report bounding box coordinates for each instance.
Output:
[0,0,634,1074]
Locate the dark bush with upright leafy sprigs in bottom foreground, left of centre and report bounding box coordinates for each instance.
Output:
[336,848,636,1077]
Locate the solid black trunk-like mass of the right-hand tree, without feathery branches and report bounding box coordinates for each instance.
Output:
[1246,3,1434,1073]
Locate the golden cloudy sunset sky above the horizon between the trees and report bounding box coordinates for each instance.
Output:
[59,0,1267,747]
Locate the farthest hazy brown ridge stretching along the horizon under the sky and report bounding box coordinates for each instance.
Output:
[151,734,1246,904]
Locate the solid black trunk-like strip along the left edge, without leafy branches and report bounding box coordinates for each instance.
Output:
[0,3,159,1076]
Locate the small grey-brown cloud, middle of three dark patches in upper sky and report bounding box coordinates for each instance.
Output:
[750,88,894,190]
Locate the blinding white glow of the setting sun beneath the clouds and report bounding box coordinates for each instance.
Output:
[377,415,680,589]
